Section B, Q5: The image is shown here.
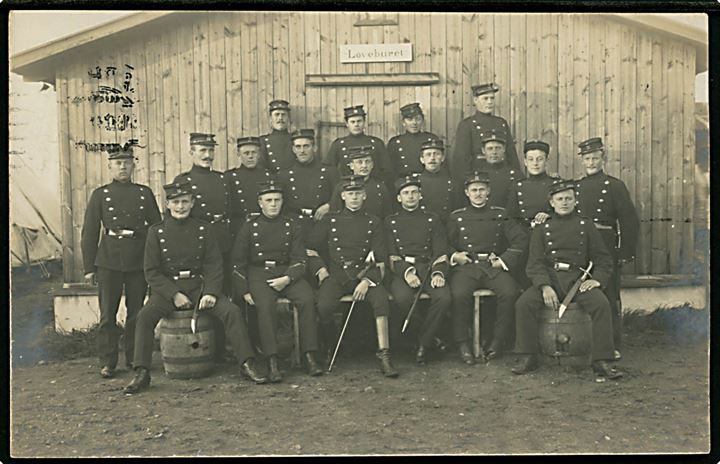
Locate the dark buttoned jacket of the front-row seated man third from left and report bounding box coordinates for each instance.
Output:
[307,208,386,284]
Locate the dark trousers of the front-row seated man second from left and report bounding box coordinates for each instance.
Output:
[249,268,318,355]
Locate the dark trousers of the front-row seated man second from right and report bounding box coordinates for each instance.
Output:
[450,263,520,347]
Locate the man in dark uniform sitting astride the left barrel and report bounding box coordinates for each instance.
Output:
[125,182,266,393]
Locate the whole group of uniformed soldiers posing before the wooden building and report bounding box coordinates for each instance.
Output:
[82,83,638,393]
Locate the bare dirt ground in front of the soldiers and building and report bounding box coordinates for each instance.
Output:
[11,264,709,457]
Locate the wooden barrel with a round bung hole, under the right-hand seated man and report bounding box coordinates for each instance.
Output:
[538,303,592,366]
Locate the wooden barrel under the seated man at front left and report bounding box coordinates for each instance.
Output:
[158,311,215,379]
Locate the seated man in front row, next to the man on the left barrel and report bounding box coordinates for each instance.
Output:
[233,180,322,382]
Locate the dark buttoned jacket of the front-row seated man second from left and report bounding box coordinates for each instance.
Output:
[233,213,307,295]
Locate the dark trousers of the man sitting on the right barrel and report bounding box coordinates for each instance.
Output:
[515,287,615,360]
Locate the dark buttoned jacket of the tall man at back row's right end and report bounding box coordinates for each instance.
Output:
[450,111,520,179]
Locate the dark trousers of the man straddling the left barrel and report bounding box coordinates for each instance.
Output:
[133,289,254,369]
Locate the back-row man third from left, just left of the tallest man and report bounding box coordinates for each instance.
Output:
[387,103,438,180]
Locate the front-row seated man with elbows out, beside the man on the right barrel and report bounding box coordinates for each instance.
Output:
[448,172,527,364]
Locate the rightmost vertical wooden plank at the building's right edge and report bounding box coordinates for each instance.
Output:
[680,45,696,274]
